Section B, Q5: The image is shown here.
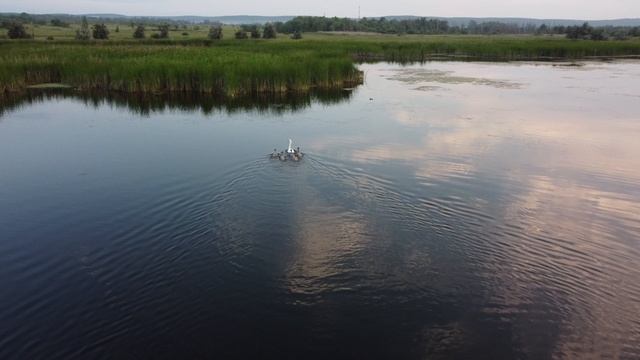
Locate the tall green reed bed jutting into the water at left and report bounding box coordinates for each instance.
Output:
[0,43,361,97]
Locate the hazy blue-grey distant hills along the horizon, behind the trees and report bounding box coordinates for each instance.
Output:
[0,13,640,27]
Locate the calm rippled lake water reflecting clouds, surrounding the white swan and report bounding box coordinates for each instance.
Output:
[0,62,640,359]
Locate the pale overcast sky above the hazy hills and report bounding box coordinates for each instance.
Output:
[5,0,640,20]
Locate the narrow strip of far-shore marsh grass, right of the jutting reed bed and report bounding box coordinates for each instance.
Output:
[307,34,640,62]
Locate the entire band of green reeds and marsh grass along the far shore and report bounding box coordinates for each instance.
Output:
[0,34,640,97]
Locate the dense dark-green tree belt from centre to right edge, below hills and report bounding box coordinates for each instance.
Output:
[275,16,640,40]
